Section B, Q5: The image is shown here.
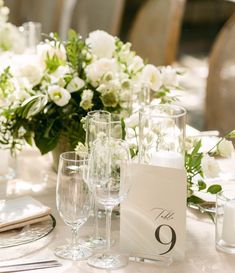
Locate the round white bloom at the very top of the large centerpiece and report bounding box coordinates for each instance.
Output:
[86,30,115,58]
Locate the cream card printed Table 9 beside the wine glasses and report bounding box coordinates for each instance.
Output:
[120,163,186,260]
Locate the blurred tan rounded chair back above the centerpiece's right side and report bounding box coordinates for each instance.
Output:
[128,0,186,65]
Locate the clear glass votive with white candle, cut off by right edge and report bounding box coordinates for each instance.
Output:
[215,190,235,254]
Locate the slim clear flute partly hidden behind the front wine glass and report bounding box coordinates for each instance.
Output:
[84,110,111,249]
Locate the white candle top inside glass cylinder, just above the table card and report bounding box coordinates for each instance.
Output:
[151,151,184,169]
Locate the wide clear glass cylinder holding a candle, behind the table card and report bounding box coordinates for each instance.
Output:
[139,104,186,169]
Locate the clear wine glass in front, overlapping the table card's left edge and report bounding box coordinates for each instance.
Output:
[88,138,131,269]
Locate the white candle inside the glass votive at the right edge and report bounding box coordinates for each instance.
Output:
[222,199,235,245]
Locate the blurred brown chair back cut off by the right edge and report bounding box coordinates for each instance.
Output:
[205,14,235,135]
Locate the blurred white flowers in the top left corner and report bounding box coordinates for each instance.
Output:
[0,0,25,54]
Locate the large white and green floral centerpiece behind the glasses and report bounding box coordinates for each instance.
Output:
[0,30,178,154]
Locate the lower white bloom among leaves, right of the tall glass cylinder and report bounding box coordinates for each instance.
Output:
[201,154,220,178]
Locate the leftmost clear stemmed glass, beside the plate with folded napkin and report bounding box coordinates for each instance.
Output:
[55,152,92,260]
